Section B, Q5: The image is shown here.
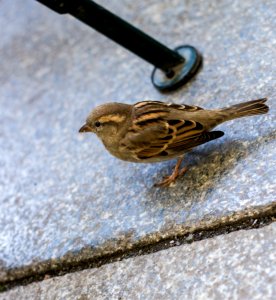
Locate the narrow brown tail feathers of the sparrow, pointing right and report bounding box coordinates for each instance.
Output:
[220,98,269,121]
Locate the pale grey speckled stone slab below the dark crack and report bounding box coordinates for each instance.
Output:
[0,223,276,300]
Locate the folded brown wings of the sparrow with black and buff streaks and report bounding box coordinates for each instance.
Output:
[121,101,223,160]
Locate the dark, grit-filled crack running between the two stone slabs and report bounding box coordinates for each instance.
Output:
[0,206,276,292]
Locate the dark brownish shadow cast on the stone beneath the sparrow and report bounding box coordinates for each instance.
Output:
[143,130,276,205]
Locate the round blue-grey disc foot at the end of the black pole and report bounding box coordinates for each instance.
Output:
[151,45,202,92]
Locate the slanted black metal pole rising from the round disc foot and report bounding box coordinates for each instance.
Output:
[37,0,201,90]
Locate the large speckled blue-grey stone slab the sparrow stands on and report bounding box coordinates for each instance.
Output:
[0,0,276,281]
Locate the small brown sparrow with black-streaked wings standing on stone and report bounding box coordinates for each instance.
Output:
[79,98,269,187]
